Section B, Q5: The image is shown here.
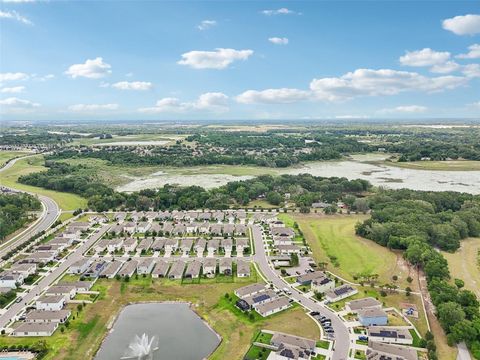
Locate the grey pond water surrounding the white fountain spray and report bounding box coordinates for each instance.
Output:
[95,303,220,360]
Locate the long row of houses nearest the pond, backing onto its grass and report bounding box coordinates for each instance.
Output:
[69,257,255,280]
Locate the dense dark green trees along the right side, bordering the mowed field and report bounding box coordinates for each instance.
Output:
[356,190,480,359]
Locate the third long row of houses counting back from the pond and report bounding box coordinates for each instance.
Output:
[110,221,248,236]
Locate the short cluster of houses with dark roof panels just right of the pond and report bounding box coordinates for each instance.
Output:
[235,284,291,317]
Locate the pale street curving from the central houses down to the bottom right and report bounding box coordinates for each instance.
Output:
[251,225,350,360]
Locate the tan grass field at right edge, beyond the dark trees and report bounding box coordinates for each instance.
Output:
[442,238,480,296]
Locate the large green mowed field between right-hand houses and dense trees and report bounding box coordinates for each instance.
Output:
[283,214,408,286]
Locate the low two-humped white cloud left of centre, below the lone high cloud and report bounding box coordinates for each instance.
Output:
[138,92,229,114]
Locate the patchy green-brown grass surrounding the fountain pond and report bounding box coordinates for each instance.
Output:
[0,277,320,360]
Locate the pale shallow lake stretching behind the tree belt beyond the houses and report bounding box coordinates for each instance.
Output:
[118,158,480,194]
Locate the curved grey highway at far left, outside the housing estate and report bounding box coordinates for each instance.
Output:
[0,155,60,258]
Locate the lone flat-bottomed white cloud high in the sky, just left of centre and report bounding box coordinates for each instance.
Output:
[178,48,253,70]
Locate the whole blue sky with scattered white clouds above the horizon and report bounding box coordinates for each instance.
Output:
[0,0,480,120]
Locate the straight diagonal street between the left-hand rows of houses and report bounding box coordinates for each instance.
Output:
[0,225,110,329]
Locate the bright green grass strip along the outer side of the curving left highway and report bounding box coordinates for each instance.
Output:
[0,155,87,210]
